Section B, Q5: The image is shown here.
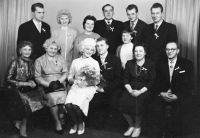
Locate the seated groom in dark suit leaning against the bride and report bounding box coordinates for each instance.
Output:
[89,37,122,128]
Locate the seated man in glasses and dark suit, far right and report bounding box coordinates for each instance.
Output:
[154,42,194,137]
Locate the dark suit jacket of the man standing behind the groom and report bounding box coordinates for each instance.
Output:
[93,19,123,55]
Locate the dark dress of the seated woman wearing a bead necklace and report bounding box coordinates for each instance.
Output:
[120,59,156,115]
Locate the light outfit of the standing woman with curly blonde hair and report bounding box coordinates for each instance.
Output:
[51,26,77,70]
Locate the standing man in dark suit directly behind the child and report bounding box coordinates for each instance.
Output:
[124,4,147,44]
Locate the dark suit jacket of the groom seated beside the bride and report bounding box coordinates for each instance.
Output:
[96,53,122,94]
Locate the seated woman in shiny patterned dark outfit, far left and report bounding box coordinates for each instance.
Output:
[5,41,44,137]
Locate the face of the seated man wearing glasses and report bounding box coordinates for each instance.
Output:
[165,43,179,60]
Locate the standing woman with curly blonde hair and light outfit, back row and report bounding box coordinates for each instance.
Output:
[51,9,77,69]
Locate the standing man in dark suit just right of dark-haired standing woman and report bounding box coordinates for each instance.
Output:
[94,4,123,55]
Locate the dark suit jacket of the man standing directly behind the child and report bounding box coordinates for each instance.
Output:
[124,19,147,44]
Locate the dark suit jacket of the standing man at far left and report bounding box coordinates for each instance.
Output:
[17,20,51,60]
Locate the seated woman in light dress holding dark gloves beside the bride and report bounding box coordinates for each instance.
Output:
[35,39,68,135]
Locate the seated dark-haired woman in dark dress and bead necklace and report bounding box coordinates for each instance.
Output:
[120,43,156,137]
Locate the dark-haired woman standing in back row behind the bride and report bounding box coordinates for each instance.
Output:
[73,15,100,59]
